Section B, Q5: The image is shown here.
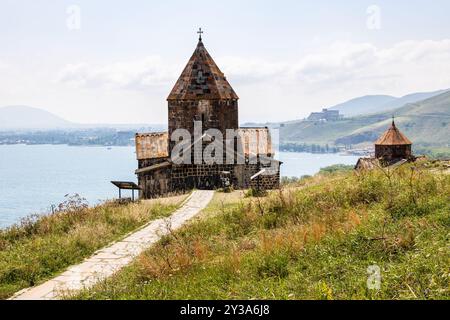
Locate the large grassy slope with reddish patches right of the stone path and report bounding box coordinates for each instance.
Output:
[74,164,450,299]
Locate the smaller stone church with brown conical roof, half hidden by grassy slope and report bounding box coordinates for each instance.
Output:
[355,119,416,170]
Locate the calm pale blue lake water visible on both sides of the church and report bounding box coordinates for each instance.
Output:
[0,145,357,228]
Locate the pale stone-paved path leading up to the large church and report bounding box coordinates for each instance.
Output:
[12,191,214,300]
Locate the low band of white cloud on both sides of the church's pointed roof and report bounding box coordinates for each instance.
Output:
[58,39,450,94]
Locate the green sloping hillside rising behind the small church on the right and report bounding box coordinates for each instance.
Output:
[280,92,450,147]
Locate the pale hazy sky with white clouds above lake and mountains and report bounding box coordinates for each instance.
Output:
[0,0,450,123]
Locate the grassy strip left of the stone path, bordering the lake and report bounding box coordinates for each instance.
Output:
[0,198,176,299]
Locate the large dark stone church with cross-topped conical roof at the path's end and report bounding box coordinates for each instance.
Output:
[136,30,281,199]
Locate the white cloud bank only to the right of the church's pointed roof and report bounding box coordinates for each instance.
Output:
[223,40,450,87]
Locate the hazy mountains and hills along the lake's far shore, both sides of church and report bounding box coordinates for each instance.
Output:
[0,90,450,147]
